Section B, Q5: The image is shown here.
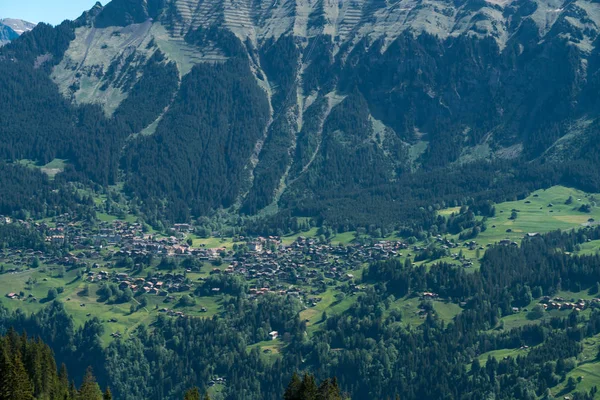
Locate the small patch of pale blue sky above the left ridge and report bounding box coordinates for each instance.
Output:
[0,0,102,25]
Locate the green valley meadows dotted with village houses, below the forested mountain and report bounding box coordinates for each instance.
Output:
[0,186,600,399]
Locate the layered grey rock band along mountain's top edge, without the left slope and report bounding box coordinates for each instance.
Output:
[88,0,600,48]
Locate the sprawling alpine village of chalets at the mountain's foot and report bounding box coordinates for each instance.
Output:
[0,215,420,317]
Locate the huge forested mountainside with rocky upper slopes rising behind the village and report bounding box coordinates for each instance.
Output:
[0,0,600,227]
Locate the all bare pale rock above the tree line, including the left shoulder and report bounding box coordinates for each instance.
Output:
[54,0,600,121]
